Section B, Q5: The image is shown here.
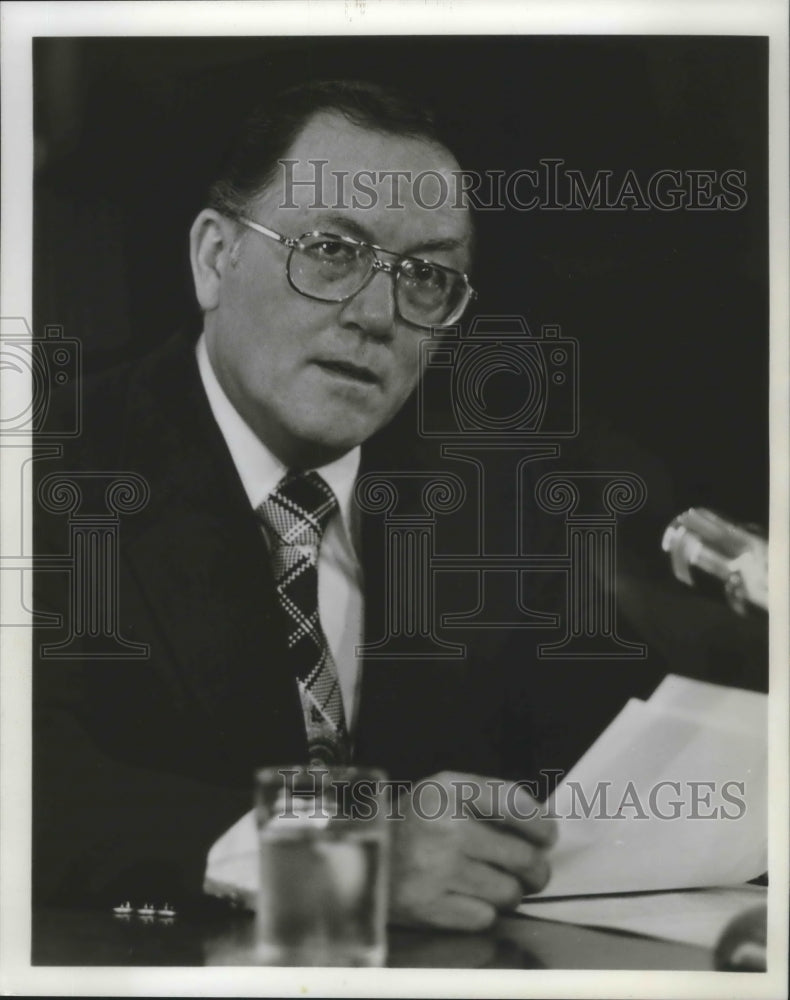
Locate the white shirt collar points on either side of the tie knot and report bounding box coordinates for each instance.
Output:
[196,333,360,537]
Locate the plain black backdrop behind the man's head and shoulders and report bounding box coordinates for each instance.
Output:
[34,36,768,523]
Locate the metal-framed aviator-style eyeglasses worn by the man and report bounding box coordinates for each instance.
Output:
[230,216,477,330]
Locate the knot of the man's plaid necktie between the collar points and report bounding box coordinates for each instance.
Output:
[258,472,337,548]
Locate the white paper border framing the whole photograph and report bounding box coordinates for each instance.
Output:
[0,0,790,1000]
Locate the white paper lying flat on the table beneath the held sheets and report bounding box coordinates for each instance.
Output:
[518,885,767,948]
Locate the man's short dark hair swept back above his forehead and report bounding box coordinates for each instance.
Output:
[208,80,445,217]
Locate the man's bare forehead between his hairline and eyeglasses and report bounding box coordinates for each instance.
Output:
[260,112,472,251]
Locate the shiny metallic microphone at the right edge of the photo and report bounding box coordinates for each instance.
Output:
[661,507,768,615]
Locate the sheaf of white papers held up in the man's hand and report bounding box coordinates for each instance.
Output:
[520,675,767,939]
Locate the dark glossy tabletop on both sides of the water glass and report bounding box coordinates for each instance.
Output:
[32,908,713,970]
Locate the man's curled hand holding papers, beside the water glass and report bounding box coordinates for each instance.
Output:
[390,772,556,931]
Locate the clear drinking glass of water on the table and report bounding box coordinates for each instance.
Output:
[255,765,389,967]
